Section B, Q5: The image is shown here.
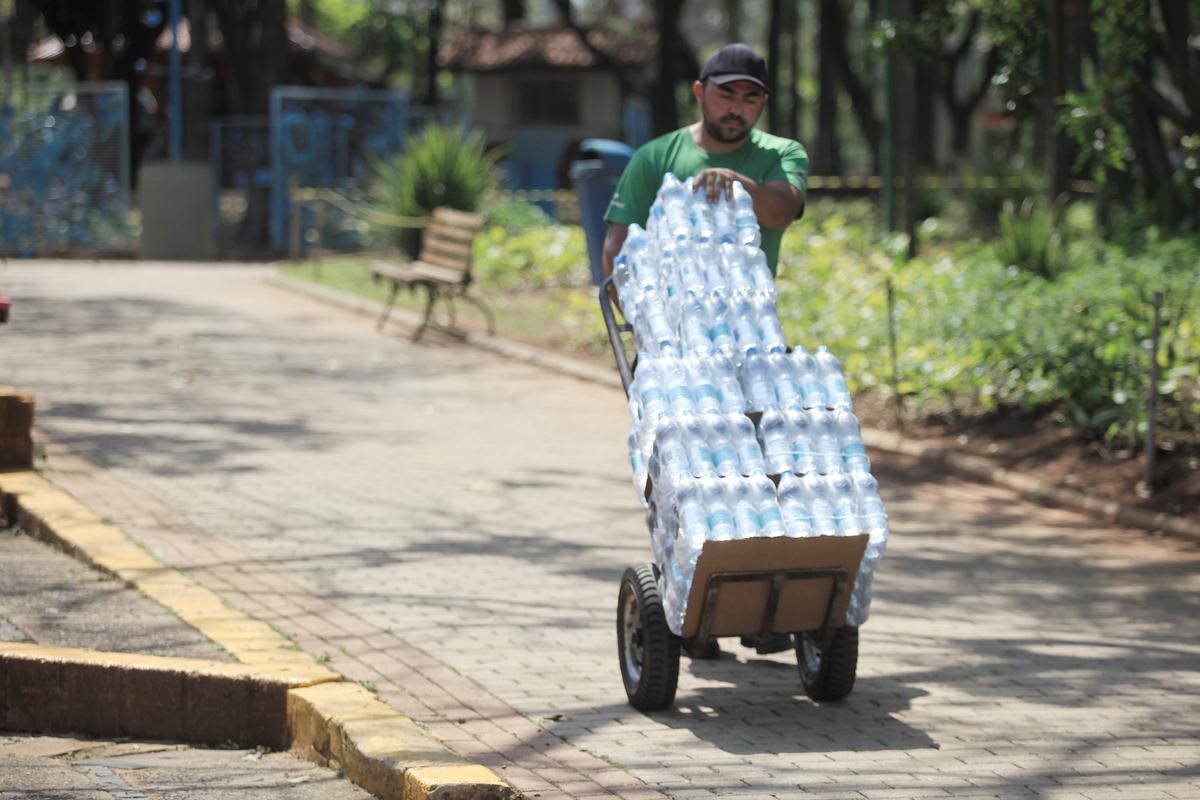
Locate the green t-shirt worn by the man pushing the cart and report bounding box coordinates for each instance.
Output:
[604,127,809,272]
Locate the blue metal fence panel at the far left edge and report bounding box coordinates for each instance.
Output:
[0,83,132,258]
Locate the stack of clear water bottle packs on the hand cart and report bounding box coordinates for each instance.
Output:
[613,174,888,634]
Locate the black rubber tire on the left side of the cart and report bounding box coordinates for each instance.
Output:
[617,564,679,711]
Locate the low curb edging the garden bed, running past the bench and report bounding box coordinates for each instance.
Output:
[268,268,1200,541]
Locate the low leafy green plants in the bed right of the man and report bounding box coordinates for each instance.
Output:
[779,206,1200,444]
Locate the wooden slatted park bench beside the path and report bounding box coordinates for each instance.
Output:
[371,207,496,342]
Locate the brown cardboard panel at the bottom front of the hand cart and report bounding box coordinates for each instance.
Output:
[682,534,868,637]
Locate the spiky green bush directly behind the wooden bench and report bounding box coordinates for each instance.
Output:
[370,125,500,257]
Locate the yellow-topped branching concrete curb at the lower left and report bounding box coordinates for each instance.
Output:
[0,471,516,800]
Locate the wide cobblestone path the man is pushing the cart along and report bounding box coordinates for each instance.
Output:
[0,263,1200,800]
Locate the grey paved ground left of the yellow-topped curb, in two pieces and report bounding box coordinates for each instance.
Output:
[0,528,371,800]
